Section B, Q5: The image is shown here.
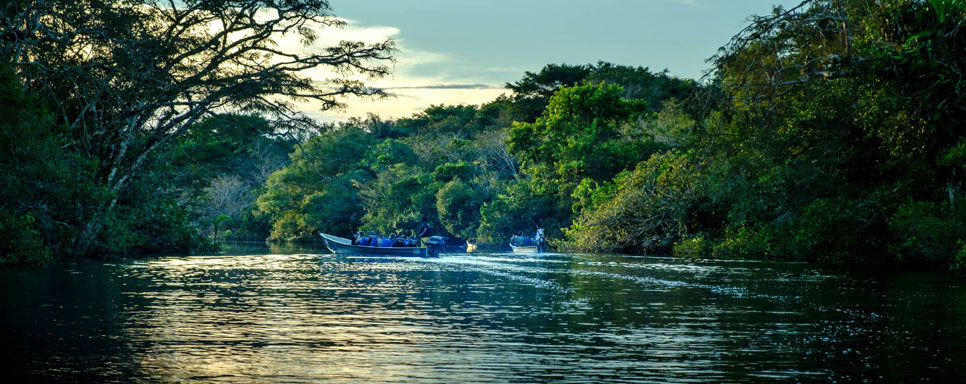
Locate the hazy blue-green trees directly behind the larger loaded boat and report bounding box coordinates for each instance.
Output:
[251,106,515,240]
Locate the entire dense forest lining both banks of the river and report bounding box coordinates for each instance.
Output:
[0,0,966,269]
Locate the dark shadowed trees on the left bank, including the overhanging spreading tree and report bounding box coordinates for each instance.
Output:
[0,0,394,263]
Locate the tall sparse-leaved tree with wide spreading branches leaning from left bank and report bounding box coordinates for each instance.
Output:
[0,0,393,253]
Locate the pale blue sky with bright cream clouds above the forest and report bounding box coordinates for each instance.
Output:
[302,0,801,121]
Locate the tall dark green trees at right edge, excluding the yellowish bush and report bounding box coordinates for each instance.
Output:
[702,0,966,263]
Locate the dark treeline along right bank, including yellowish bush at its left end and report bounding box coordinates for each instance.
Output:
[567,0,966,268]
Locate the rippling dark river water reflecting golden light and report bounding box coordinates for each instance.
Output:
[0,247,966,383]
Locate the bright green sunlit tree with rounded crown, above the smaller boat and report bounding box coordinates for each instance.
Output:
[501,84,658,232]
